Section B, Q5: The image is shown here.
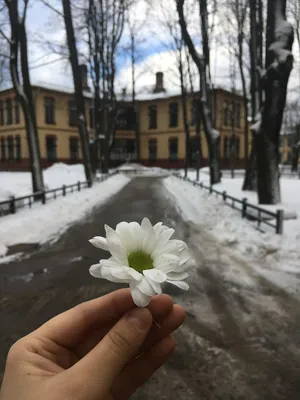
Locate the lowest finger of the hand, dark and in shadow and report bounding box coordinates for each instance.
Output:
[112,335,175,400]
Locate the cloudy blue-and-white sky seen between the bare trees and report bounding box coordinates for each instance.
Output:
[0,0,300,104]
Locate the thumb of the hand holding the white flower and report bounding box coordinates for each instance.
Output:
[64,308,152,399]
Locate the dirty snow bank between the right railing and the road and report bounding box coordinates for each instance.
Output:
[164,177,300,280]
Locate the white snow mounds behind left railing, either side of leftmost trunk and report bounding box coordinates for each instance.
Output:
[0,163,86,201]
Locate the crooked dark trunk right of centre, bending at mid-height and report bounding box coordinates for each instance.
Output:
[177,0,220,185]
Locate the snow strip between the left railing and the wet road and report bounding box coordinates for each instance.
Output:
[0,173,130,256]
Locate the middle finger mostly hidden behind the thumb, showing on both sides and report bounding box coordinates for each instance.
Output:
[73,295,173,358]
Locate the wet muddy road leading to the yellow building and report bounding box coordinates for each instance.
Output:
[0,177,300,400]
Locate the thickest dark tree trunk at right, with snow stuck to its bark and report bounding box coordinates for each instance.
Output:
[255,0,293,204]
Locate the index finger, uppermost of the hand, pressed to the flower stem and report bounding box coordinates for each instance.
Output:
[34,289,134,347]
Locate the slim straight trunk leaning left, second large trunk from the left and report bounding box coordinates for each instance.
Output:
[62,0,93,182]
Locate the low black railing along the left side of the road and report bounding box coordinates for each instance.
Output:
[0,171,118,217]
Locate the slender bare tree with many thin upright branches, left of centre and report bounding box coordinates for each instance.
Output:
[86,0,129,172]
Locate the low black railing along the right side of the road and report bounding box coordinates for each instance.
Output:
[176,175,284,235]
